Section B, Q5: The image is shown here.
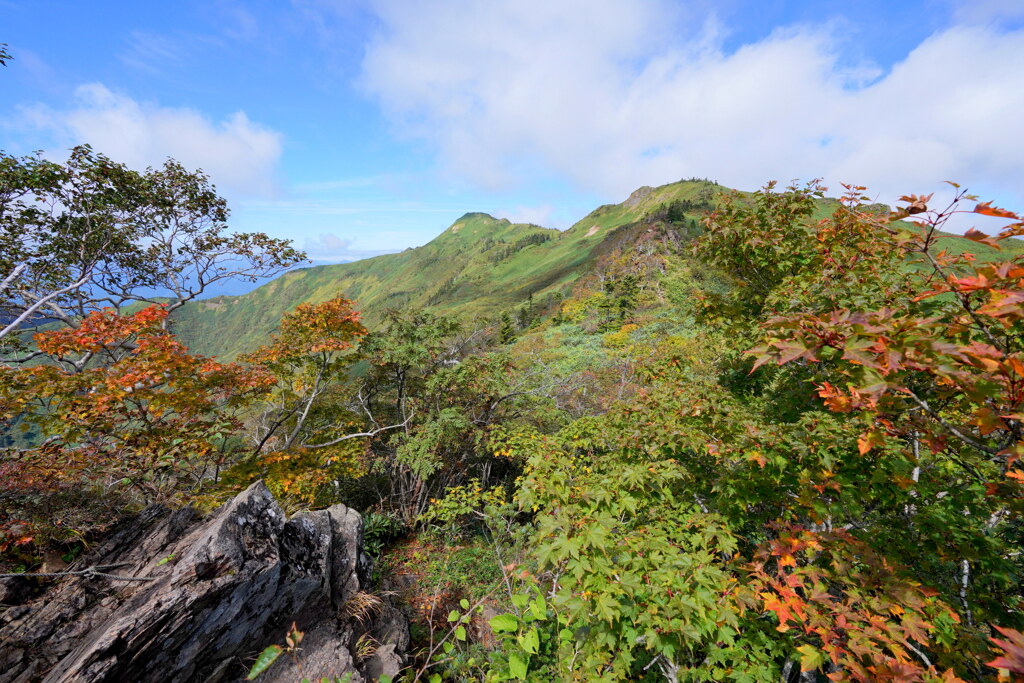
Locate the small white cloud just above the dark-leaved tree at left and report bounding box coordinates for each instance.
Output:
[15,83,282,196]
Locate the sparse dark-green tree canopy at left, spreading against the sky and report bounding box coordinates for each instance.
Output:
[0,145,303,370]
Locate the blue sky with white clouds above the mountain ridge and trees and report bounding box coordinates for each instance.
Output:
[0,0,1024,260]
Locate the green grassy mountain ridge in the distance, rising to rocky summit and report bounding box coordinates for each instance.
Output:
[174,180,1019,358]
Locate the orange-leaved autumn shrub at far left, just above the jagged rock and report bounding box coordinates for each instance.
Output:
[0,306,269,557]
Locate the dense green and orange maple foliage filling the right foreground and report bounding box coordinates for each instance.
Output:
[483,183,1024,681]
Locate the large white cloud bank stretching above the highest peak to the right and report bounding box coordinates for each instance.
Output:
[362,0,1024,208]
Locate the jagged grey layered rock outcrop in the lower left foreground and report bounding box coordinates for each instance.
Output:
[0,482,409,683]
